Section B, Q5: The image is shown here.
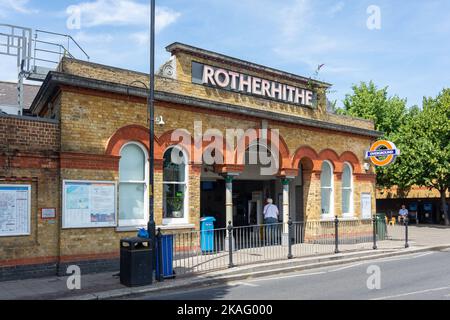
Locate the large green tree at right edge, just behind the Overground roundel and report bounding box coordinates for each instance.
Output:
[386,89,450,225]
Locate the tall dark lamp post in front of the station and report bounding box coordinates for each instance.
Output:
[147,0,156,245]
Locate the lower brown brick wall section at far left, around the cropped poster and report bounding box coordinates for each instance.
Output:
[0,115,60,280]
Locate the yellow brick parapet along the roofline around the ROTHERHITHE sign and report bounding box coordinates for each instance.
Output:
[59,57,374,130]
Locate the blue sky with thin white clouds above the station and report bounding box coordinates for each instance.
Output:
[0,0,450,106]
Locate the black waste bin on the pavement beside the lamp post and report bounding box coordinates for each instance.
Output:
[120,237,153,287]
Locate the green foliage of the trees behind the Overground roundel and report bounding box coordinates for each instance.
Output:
[338,82,450,210]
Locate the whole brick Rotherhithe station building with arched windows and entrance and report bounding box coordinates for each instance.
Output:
[0,43,380,280]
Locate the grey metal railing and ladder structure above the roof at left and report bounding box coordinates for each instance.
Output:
[0,24,90,114]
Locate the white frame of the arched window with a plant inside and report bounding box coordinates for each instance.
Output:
[162,146,189,225]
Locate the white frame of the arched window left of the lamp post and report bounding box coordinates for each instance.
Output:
[117,141,150,229]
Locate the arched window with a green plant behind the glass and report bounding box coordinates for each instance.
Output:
[163,147,188,224]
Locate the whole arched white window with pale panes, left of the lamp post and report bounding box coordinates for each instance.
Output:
[119,142,149,226]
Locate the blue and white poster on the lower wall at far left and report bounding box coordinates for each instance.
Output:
[0,184,31,237]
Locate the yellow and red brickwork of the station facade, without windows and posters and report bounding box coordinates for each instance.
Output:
[0,43,376,279]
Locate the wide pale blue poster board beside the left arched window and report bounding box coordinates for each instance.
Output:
[63,180,116,228]
